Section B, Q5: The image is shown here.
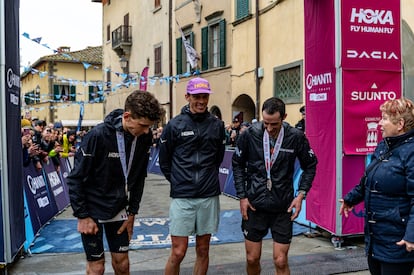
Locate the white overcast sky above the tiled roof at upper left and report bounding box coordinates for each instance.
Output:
[19,0,102,66]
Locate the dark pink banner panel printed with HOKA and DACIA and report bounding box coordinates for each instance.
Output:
[341,0,401,71]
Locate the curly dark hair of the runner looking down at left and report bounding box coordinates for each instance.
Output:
[124,90,165,121]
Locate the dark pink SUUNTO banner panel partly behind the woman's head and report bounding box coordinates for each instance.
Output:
[342,70,401,155]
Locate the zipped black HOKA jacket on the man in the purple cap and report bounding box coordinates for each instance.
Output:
[159,106,226,198]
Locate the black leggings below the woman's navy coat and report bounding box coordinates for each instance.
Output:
[368,256,414,275]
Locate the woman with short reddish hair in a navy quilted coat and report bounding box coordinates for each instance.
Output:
[340,98,414,275]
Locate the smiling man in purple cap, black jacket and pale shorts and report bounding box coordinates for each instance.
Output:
[159,77,225,274]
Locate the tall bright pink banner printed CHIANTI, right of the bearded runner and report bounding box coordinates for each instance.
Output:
[304,0,337,235]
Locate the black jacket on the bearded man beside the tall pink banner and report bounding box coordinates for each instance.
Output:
[232,122,318,212]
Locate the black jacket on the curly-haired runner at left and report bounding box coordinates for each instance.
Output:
[67,109,152,219]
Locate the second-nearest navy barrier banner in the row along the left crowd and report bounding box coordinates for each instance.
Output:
[43,161,69,212]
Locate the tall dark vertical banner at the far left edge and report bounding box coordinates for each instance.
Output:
[0,0,25,263]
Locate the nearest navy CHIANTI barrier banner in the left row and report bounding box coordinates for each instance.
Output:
[23,165,57,232]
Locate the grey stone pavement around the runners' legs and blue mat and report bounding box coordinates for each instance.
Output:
[5,174,369,275]
